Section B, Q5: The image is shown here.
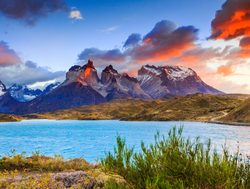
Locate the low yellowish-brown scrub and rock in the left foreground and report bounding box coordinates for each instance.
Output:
[0,153,123,189]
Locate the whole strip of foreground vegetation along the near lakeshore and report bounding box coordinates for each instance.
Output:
[0,128,250,189]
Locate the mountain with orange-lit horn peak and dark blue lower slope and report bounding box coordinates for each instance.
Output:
[15,61,106,114]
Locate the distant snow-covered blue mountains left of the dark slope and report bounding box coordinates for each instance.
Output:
[8,82,60,102]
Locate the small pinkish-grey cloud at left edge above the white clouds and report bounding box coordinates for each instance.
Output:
[0,41,21,67]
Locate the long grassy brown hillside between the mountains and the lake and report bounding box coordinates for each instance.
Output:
[29,94,246,121]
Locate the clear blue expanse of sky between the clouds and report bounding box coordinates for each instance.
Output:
[0,0,223,70]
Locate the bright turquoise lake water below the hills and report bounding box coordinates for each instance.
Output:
[0,120,250,162]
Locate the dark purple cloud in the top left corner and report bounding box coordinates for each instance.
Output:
[0,0,68,25]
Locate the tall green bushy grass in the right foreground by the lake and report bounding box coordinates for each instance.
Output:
[101,128,250,189]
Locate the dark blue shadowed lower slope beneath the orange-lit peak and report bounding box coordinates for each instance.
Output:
[17,82,105,114]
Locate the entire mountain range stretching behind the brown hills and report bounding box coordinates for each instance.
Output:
[0,60,222,114]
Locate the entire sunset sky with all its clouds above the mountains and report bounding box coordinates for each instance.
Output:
[0,0,250,93]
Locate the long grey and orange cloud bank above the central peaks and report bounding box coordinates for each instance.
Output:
[79,20,198,64]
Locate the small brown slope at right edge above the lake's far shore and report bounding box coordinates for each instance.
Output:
[221,98,250,123]
